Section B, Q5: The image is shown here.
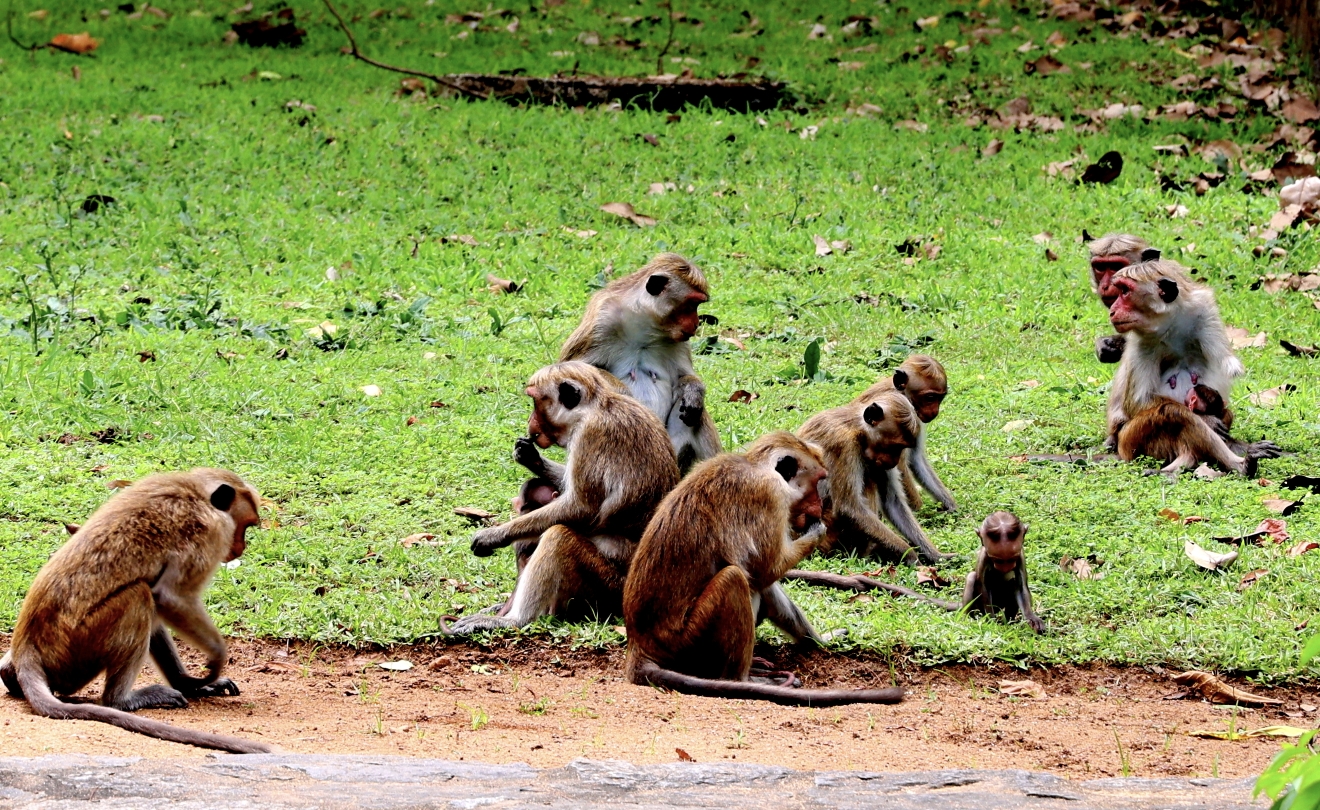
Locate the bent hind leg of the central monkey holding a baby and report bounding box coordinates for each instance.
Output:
[447,525,626,635]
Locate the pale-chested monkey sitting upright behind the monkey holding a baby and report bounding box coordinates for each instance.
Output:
[513,253,719,482]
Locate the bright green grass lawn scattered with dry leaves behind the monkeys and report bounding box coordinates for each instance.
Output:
[0,0,1320,681]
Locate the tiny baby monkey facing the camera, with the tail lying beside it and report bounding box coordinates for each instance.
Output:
[784,512,1045,633]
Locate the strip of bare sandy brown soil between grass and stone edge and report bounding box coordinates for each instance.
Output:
[0,639,1320,777]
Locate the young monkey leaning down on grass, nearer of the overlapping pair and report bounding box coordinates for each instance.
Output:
[797,390,948,565]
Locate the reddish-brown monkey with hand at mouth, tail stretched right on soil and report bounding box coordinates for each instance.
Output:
[623,433,903,706]
